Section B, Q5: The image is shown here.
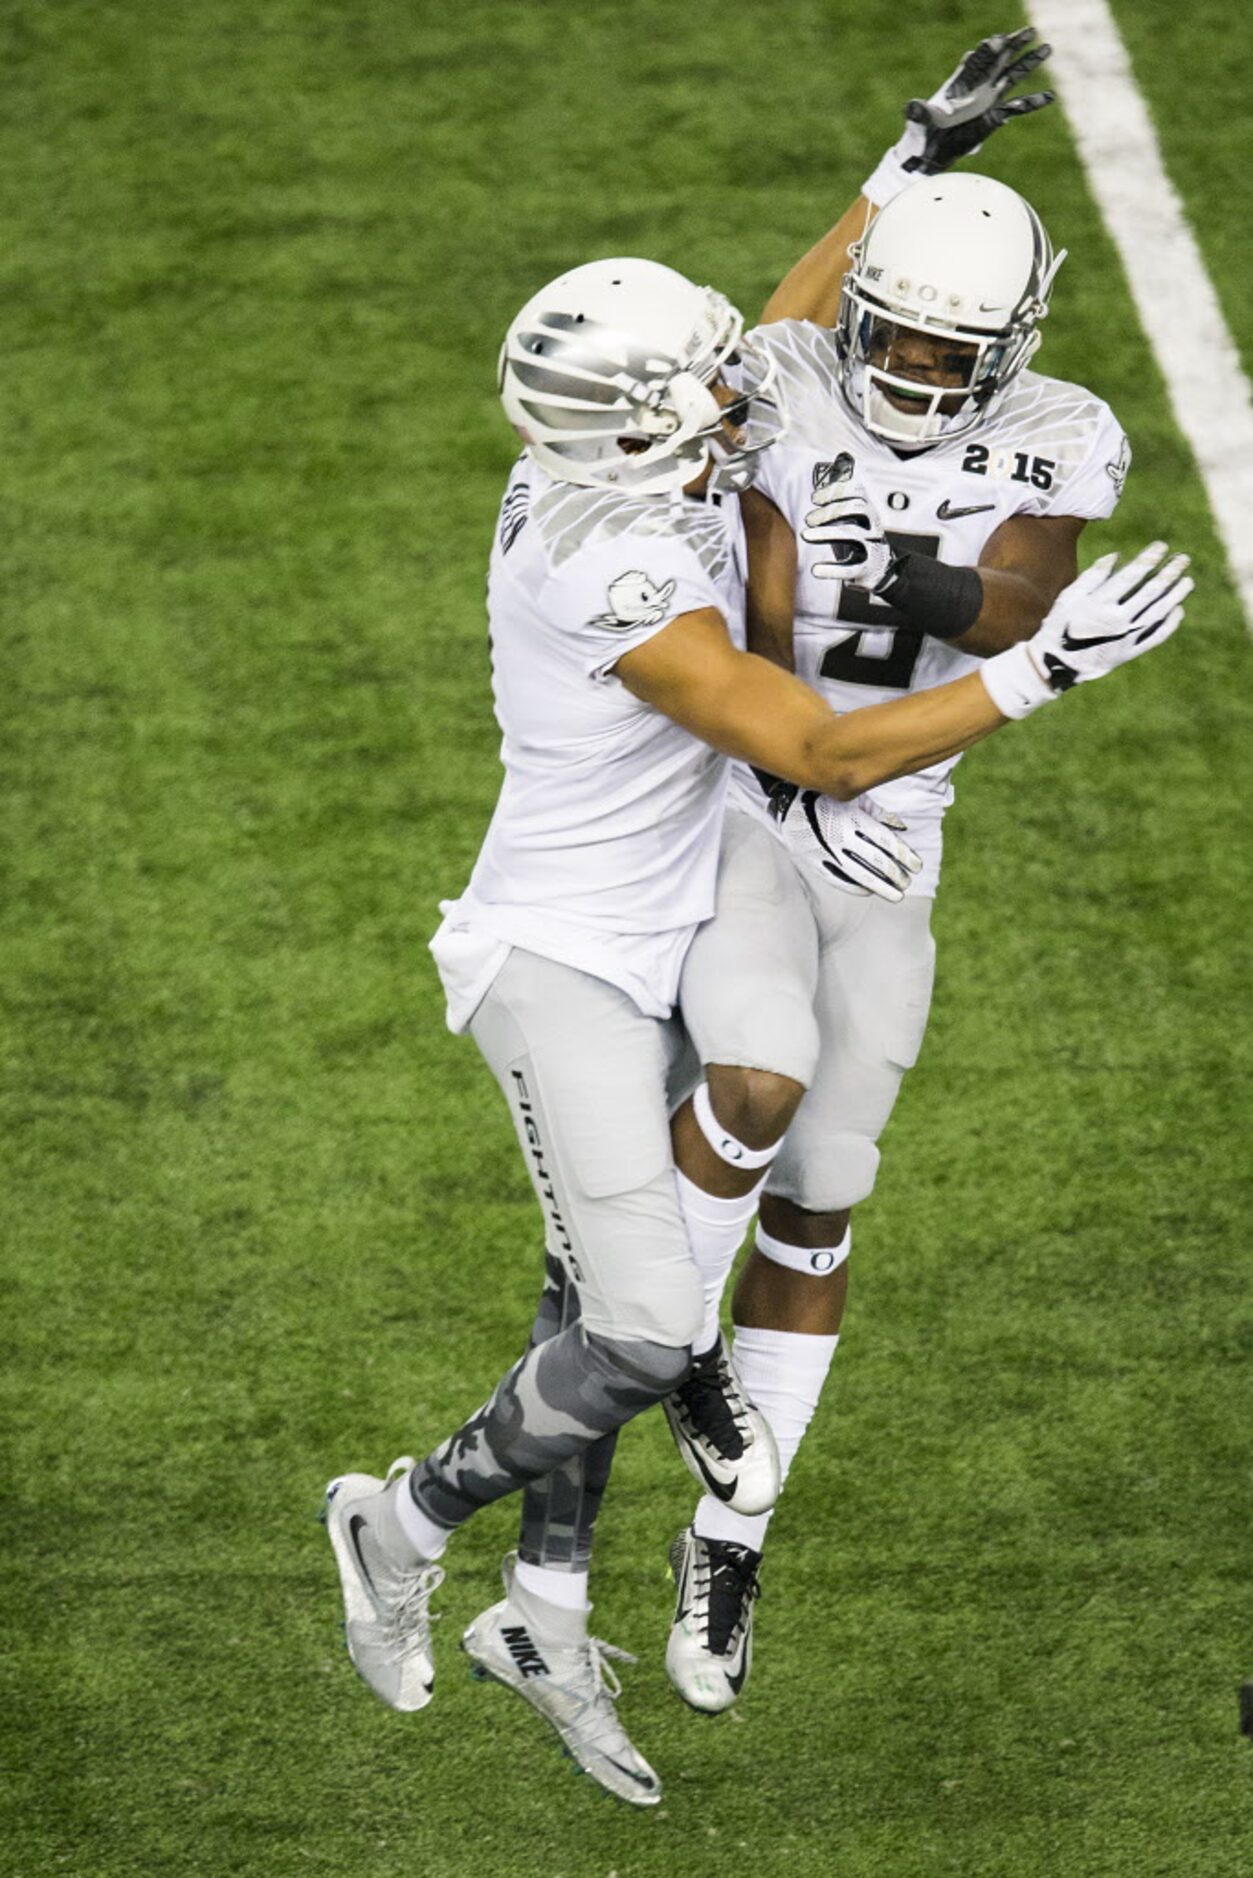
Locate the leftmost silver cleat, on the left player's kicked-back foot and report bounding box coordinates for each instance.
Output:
[327,1455,443,1711]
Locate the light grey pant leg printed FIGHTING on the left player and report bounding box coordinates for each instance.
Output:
[470,948,703,1347]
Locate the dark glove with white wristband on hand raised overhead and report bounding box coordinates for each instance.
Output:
[862,26,1054,208]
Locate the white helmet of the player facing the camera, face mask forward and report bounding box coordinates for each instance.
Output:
[836,171,1065,449]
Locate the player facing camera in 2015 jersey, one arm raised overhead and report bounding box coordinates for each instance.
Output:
[667,30,1164,1711]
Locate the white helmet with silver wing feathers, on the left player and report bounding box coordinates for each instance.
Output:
[500,259,783,496]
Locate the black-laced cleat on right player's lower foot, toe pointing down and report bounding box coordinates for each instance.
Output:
[665,1527,761,1715]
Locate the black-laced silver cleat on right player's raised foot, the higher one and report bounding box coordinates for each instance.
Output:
[661,1335,780,1514]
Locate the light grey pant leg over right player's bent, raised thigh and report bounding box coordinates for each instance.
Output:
[678,809,819,1087]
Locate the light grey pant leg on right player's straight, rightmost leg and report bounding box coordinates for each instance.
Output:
[768,894,936,1213]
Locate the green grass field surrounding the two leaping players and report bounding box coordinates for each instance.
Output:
[0,0,1253,1878]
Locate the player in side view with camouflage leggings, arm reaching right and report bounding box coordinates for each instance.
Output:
[327,238,1187,1805]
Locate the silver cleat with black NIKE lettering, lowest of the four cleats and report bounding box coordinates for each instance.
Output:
[462,1553,661,1807]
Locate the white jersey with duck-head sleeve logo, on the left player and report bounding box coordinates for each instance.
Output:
[432,456,746,1029]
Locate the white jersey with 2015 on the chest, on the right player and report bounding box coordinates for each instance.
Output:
[735,319,1131,894]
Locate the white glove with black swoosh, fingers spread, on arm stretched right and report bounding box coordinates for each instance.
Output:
[981,541,1197,717]
